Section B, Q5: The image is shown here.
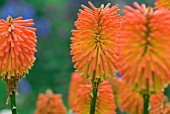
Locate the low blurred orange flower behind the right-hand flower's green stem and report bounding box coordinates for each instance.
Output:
[119,80,166,114]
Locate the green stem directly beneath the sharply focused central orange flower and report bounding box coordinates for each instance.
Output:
[90,84,98,114]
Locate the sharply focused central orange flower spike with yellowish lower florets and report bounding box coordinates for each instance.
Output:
[70,2,120,82]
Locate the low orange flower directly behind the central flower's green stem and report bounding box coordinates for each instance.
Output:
[72,81,116,114]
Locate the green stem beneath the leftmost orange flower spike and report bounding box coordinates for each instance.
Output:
[10,91,17,114]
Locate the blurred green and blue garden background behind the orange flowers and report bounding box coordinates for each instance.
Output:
[0,0,168,114]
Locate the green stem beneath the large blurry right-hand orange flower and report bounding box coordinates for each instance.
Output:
[143,94,150,114]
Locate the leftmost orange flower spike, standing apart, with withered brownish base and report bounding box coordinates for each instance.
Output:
[0,16,37,94]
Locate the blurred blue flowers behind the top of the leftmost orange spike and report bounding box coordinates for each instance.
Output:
[0,1,50,37]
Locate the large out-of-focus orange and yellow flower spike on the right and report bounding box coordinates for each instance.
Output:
[117,2,170,93]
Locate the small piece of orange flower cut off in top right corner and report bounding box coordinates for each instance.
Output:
[155,0,170,10]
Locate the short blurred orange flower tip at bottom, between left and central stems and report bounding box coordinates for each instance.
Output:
[35,90,67,114]
